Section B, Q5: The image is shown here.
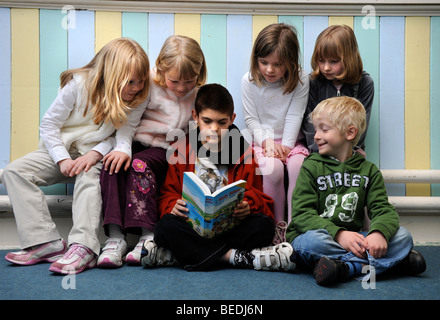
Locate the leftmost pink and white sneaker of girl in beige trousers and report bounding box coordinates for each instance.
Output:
[5,239,67,266]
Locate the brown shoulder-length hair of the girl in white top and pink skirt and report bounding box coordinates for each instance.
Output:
[250,23,301,94]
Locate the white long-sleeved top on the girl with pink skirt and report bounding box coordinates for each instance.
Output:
[241,70,309,148]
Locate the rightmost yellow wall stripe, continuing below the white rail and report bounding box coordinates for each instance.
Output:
[405,17,430,196]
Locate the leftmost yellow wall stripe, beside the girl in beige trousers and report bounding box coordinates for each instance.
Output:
[11,9,40,161]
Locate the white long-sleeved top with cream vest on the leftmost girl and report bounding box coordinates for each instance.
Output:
[40,74,147,163]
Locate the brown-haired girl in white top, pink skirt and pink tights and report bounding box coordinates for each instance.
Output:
[242,23,309,232]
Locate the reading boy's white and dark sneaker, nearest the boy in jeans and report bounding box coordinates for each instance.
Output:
[252,242,295,271]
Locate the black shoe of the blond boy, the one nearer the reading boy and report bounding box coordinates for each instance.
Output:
[313,257,349,286]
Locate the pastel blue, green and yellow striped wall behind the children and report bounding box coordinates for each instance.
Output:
[0,8,440,195]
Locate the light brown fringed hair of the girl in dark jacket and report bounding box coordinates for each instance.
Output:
[311,25,363,84]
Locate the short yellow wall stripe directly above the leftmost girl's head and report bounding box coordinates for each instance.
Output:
[95,11,122,52]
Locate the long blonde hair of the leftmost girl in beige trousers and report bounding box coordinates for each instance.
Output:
[60,38,150,128]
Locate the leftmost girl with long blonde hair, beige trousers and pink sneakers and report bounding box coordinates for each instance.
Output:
[3,38,149,274]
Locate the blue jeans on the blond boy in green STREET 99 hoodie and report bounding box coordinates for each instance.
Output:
[292,227,413,274]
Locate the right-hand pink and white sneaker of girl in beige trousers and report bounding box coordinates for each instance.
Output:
[49,244,96,274]
